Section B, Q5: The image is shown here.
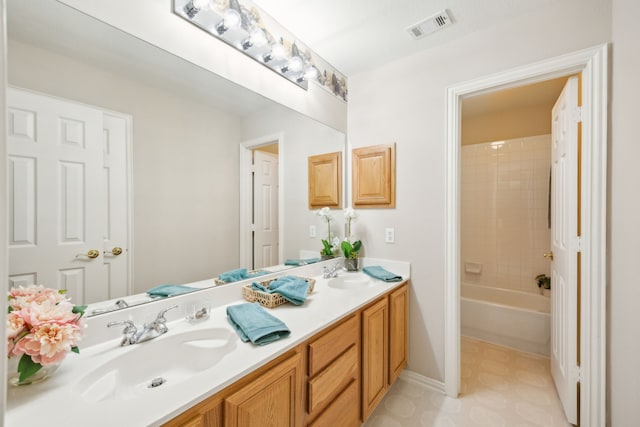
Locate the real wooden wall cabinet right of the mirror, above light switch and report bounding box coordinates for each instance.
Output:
[352,144,396,208]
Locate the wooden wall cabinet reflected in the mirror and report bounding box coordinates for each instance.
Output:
[309,151,342,209]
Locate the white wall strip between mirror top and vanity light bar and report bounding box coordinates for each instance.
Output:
[60,0,347,131]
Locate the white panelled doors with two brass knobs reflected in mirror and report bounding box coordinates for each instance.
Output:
[8,89,130,304]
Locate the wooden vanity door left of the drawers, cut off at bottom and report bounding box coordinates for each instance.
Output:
[224,353,303,427]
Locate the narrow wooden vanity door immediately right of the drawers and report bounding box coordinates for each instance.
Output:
[362,297,389,421]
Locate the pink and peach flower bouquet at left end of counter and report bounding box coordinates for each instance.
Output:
[7,285,86,382]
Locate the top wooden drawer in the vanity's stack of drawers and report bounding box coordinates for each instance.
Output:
[309,316,359,377]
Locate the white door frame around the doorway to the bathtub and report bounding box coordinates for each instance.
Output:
[444,44,609,427]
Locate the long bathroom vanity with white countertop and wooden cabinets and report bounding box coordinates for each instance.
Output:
[6,259,409,426]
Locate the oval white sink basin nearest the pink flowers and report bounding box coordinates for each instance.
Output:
[76,328,238,403]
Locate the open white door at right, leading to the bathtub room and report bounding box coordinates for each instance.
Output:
[551,77,579,424]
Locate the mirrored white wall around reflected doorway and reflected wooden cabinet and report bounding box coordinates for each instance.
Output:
[242,107,346,260]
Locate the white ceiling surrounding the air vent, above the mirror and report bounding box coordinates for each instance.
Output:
[251,0,562,76]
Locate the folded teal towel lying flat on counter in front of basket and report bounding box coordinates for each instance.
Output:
[227,302,291,345]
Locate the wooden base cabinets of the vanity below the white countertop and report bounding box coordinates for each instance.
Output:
[165,284,409,427]
